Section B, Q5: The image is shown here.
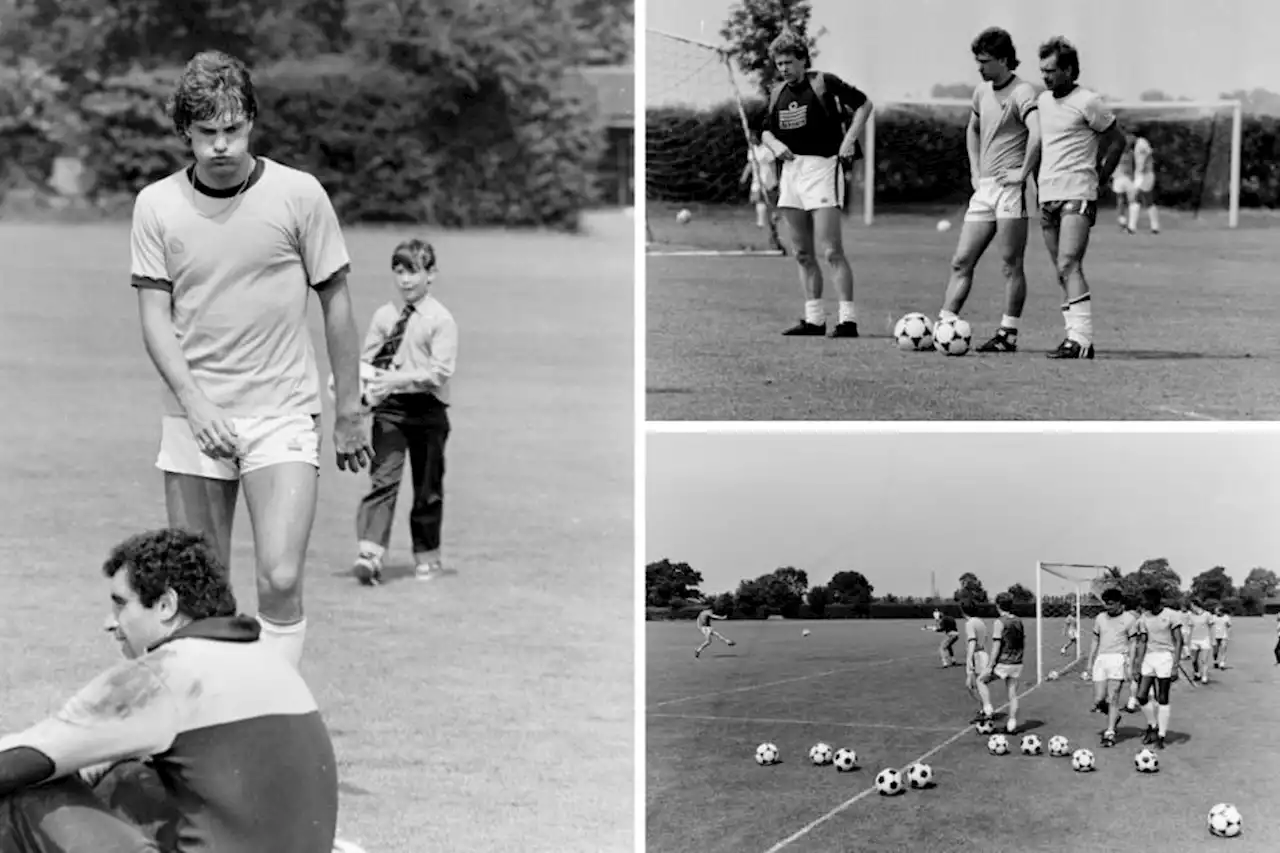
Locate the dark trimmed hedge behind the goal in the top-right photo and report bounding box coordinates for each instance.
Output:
[645,101,1280,207]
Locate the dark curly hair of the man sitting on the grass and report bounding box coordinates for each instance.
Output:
[102,528,236,619]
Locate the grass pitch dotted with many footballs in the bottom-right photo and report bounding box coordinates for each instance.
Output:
[645,619,1280,853]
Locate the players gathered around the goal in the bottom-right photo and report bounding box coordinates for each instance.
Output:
[933,587,1231,749]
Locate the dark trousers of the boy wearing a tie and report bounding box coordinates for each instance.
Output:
[356,394,449,555]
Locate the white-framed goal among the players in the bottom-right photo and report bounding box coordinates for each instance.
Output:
[1036,562,1120,684]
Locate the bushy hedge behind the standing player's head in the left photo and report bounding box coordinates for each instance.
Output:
[0,56,605,228]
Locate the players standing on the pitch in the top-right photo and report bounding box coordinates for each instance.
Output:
[744,27,1158,359]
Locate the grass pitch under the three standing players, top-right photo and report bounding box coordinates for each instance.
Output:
[646,209,1280,420]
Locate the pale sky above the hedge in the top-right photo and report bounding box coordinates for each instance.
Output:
[645,0,1280,101]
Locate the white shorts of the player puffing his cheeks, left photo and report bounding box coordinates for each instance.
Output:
[156,415,320,480]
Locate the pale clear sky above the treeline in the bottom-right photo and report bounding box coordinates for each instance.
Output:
[644,432,1280,597]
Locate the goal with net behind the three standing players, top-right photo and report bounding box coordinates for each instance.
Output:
[863,97,1242,228]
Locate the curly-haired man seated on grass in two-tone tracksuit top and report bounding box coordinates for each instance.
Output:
[0,529,338,853]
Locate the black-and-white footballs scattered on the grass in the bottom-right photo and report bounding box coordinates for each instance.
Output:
[755,734,1244,838]
